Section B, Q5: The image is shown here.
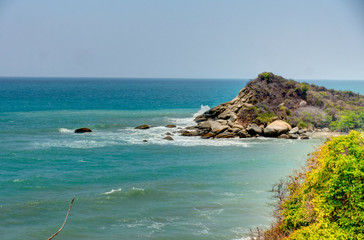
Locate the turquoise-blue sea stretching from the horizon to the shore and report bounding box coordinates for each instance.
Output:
[0,78,364,240]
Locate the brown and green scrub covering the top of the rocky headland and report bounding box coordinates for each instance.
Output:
[238,72,364,132]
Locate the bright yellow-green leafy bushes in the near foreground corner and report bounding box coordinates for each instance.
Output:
[252,131,364,240]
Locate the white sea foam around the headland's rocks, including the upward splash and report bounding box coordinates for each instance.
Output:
[37,105,251,149]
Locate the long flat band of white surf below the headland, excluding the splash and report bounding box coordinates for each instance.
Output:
[35,126,252,149]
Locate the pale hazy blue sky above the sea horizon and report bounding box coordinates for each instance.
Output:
[0,0,364,80]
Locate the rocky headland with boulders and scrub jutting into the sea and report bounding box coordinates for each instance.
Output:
[186,73,364,138]
